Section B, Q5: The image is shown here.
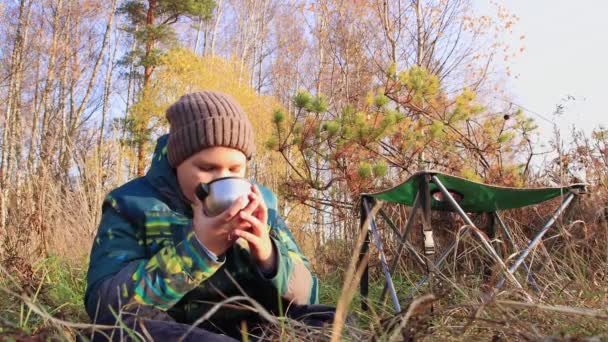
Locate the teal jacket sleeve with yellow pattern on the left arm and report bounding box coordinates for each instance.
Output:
[85,199,224,321]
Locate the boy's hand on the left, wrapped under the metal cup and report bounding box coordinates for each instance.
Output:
[192,190,255,256]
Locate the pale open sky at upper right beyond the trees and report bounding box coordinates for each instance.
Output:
[473,0,608,142]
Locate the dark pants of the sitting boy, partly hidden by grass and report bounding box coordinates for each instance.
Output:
[82,305,335,342]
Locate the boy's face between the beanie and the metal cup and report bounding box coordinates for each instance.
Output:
[176,146,247,203]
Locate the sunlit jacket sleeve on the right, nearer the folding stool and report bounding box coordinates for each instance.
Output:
[268,211,319,304]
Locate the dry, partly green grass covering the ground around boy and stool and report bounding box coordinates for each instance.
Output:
[0,199,608,341]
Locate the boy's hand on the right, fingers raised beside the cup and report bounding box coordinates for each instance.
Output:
[232,185,276,272]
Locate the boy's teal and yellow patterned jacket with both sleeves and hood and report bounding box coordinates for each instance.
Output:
[84,135,318,323]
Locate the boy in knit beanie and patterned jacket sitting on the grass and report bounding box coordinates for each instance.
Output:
[85,91,333,340]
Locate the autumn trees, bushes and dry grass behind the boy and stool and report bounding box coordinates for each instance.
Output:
[0,0,608,339]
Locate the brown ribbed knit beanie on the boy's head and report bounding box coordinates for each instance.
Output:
[167,91,255,167]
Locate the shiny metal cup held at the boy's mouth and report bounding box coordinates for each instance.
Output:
[195,177,251,216]
